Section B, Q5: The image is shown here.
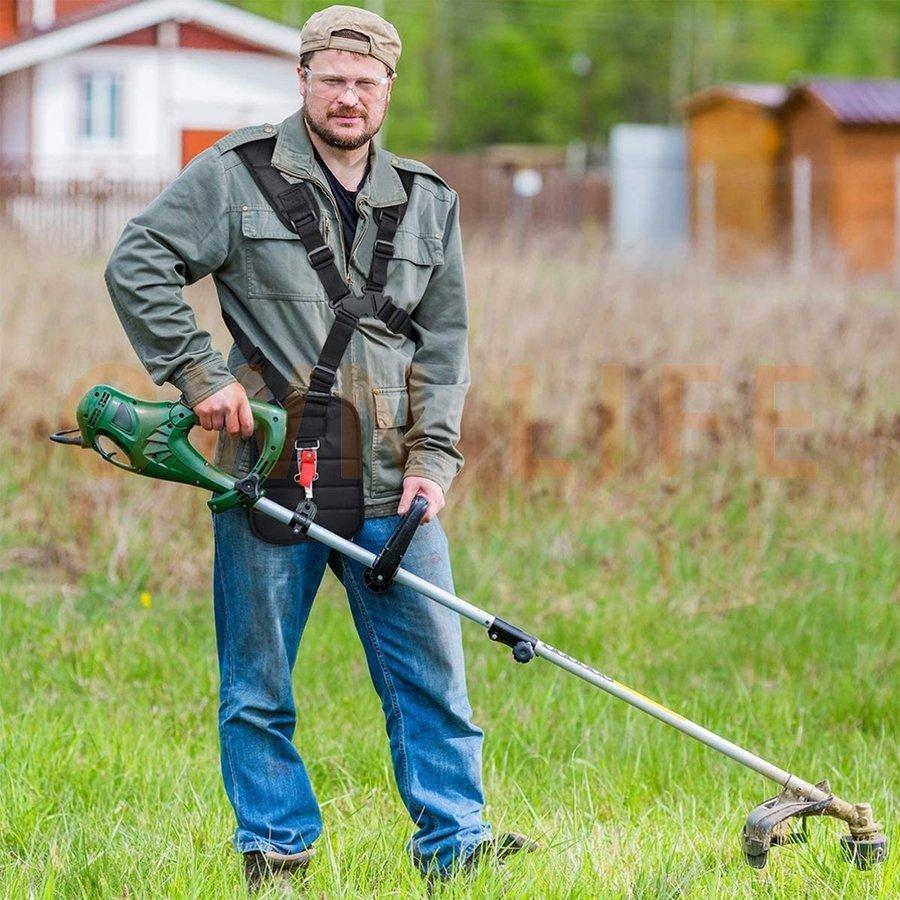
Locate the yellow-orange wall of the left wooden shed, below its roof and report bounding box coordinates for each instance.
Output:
[688,100,781,263]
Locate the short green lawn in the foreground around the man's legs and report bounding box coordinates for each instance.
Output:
[0,460,900,898]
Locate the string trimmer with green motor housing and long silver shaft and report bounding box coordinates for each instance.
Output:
[51,385,887,868]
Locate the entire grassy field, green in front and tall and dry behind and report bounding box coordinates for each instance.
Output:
[0,235,900,900]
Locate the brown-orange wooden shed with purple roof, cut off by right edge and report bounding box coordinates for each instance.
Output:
[780,79,900,275]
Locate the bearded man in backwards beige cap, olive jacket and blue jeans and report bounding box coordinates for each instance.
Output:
[106,6,526,883]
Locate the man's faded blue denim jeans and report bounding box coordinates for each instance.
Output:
[213,508,491,870]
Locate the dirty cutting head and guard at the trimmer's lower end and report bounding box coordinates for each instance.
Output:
[741,781,887,869]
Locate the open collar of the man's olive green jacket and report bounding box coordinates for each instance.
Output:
[272,110,406,207]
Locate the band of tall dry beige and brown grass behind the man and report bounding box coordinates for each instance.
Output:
[0,229,900,577]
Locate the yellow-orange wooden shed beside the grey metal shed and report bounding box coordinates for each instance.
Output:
[683,84,787,267]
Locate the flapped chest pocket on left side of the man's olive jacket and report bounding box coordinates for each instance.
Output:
[241,209,328,301]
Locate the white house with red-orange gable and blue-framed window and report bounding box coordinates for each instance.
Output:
[0,0,300,182]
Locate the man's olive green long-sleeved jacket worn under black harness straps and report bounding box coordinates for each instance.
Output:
[105,112,469,515]
